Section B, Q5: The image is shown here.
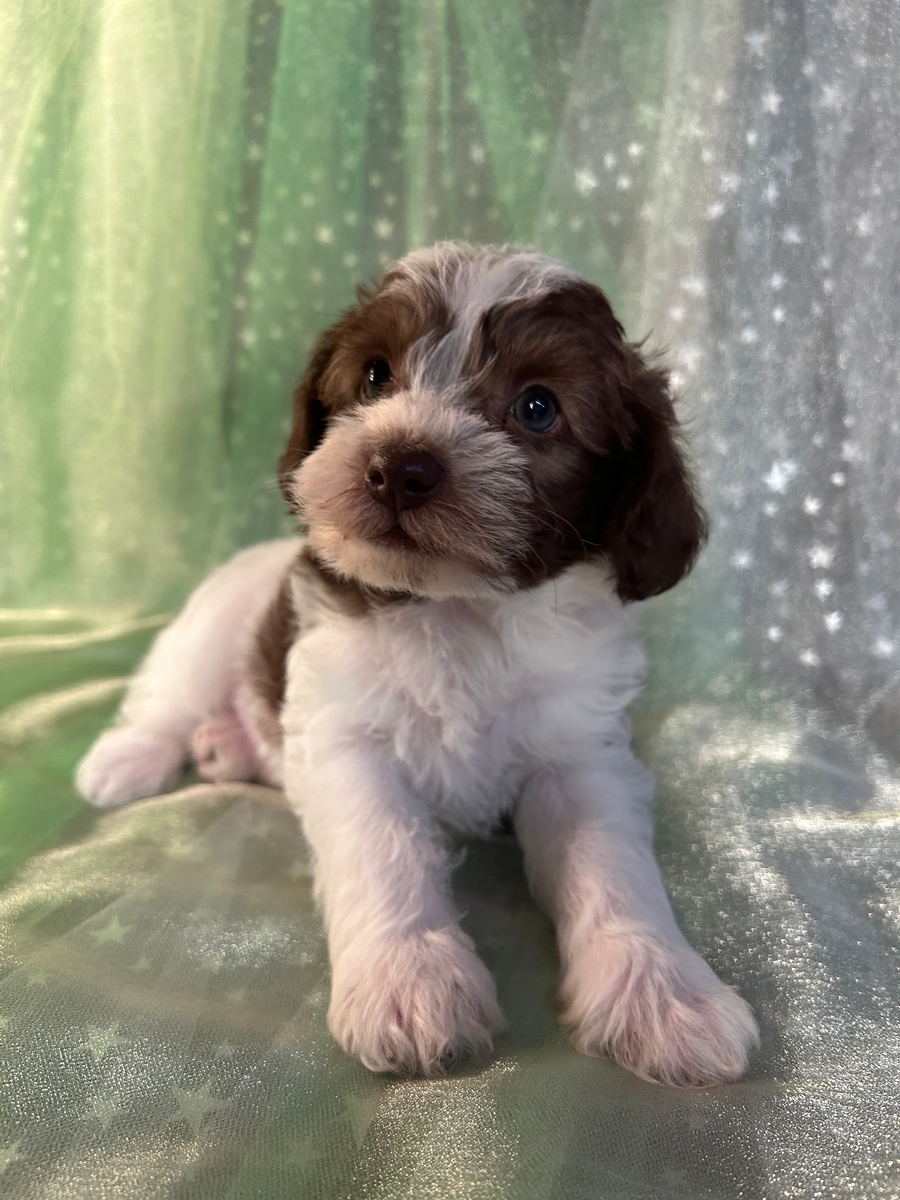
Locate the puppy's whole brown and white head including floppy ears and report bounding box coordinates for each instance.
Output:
[281,244,706,600]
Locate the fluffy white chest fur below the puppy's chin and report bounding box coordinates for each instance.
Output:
[283,566,643,829]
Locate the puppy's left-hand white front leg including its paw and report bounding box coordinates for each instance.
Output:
[284,721,503,1075]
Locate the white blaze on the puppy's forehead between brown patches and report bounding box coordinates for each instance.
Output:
[388,242,578,391]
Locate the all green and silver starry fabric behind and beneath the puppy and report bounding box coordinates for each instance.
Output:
[0,0,900,1200]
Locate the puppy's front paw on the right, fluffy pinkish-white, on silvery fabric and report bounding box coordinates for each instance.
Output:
[560,932,760,1087]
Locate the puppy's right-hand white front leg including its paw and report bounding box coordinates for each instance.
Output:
[516,750,758,1086]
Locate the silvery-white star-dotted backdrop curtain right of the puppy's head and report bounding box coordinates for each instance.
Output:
[554,0,900,752]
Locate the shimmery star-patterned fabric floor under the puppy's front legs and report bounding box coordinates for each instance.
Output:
[0,652,900,1200]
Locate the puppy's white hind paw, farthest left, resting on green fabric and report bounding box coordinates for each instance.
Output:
[76,727,184,809]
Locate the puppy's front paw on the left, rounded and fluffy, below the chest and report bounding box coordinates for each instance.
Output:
[329,929,503,1075]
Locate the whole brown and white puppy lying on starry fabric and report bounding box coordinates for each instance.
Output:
[77,244,757,1085]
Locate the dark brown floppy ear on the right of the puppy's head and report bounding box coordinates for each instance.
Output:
[601,347,708,600]
